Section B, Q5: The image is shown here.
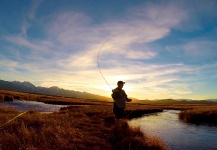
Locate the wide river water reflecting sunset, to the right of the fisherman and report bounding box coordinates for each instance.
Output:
[129,110,217,150]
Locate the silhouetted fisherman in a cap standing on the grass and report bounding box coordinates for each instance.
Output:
[112,81,132,119]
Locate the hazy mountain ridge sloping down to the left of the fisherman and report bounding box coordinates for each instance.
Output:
[0,80,111,100]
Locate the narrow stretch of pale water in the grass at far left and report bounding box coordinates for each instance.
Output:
[0,100,67,112]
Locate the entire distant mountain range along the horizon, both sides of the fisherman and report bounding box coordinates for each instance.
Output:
[0,80,217,104]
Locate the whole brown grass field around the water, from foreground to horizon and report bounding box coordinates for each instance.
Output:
[0,90,217,150]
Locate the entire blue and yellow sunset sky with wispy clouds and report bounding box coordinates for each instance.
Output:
[0,0,217,99]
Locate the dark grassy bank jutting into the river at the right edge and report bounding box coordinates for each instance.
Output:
[179,106,217,125]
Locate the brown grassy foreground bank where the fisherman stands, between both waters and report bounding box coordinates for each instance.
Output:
[0,105,167,150]
